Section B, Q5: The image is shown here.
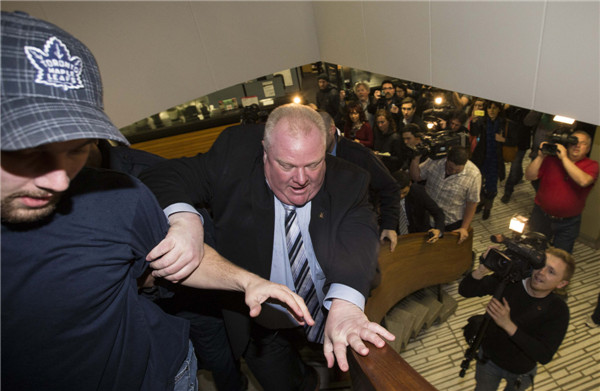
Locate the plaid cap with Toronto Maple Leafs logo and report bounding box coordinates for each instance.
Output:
[0,12,129,151]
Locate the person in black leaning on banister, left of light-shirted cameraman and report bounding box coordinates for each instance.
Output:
[392,170,445,243]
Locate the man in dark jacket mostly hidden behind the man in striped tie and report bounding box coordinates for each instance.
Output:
[319,111,400,251]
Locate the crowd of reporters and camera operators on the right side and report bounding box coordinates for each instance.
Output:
[314,71,600,390]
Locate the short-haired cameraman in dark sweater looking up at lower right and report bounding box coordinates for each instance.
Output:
[458,247,575,391]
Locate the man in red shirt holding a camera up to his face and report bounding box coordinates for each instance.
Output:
[525,130,598,253]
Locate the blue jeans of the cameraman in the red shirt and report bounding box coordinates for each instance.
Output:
[529,204,581,254]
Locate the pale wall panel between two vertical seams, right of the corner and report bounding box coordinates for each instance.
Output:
[431,2,544,107]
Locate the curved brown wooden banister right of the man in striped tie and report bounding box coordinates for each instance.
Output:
[348,230,473,391]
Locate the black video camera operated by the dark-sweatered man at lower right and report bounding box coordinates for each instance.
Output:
[480,232,548,282]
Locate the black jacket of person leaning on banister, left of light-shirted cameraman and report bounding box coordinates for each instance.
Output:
[404,183,445,233]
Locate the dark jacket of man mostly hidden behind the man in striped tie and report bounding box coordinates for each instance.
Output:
[336,137,400,229]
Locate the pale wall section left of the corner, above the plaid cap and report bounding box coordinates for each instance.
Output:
[1,1,320,127]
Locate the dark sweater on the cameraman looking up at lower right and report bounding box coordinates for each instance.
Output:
[458,274,569,374]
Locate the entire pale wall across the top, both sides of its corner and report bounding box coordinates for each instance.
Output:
[1,1,600,126]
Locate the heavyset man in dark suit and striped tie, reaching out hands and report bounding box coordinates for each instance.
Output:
[142,105,394,390]
